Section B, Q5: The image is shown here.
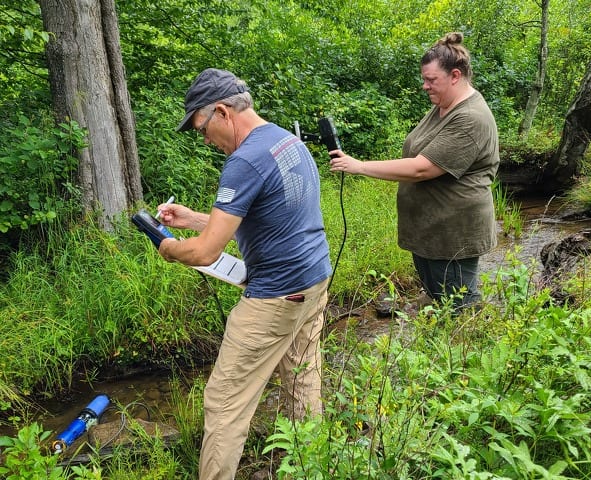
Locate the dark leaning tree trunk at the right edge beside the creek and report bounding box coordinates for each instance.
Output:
[544,61,591,191]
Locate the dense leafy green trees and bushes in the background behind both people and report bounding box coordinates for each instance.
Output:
[0,0,591,244]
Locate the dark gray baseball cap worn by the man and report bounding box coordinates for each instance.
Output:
[176,68,248,132]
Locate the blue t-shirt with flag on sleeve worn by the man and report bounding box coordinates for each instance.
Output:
[214,123,332,298]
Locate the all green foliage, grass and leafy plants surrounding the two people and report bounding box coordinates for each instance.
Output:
[0,0,591,479]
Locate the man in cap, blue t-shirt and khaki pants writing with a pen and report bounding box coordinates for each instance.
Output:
[159,68,331,480]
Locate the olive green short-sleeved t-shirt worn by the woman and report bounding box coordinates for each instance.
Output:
[398,92,499,260]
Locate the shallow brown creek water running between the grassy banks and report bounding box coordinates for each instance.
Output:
[0,193,591,448]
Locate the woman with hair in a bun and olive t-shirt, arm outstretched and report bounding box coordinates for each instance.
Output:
[330,33,499,306]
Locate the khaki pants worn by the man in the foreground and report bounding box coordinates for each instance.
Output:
[199,280,328,480]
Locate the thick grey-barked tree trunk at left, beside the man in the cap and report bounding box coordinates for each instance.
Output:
[40,0,142,229]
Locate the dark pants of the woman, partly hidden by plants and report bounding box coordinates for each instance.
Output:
[412,253,480,306]
